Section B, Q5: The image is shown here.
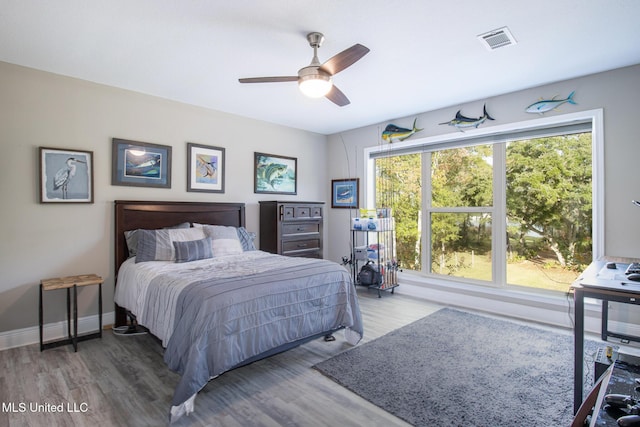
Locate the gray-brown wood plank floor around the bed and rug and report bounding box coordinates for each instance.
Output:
[0,288,440,427]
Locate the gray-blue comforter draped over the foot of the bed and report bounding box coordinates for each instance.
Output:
[158,255,363,406]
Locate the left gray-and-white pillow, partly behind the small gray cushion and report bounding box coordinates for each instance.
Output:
[136,228,207,263]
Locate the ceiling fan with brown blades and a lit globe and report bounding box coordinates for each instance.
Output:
[238,32,369,107]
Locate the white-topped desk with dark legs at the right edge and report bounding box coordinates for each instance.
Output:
[571,258,640,413]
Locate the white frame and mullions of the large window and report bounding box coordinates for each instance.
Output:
[364,109,605,288]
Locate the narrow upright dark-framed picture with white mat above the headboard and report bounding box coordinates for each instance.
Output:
[187,142,225,193]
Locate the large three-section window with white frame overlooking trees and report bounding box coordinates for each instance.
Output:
[366,110,602,291]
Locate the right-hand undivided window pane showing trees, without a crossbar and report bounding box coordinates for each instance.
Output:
[506,132,593,291]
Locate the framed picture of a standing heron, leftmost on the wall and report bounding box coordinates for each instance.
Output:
[38,147,93,203]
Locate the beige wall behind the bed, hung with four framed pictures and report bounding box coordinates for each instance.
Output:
[0,62,329,333]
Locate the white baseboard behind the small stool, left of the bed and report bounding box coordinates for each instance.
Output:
[0,311,115,351]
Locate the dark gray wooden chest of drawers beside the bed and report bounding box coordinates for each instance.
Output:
[260,201,324,258]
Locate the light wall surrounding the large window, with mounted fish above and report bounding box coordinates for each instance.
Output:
[326,65,640,260]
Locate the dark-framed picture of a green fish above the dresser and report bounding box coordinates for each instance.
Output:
[254,153,298,194]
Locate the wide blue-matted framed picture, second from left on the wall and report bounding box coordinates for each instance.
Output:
[111,138,171,188]
